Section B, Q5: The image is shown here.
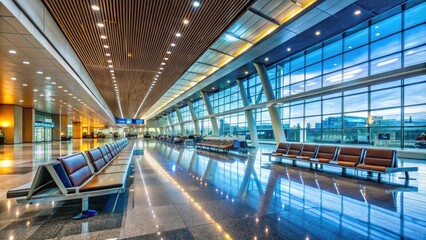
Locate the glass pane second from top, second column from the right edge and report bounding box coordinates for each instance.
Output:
[371,33,401,59]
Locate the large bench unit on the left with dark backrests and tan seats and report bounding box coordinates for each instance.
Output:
[7,139,133,219]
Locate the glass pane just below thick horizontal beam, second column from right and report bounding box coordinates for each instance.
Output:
[370,88,401,109]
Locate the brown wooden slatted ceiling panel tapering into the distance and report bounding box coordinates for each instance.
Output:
[43,0,253,118]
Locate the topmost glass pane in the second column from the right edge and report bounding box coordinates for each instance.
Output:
[371,14,401,41]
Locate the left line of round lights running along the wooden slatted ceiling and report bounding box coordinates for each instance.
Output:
[91,1,123,118]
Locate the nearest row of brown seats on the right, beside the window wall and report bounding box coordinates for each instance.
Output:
[264,143,418,181]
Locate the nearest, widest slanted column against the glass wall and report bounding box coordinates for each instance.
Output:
[253,63,285,144]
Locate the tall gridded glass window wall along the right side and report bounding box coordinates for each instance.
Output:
[158,3,426,148]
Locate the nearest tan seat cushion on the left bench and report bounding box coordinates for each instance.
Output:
[80,173,126,192]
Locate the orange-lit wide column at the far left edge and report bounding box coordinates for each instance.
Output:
[0,105,22,144]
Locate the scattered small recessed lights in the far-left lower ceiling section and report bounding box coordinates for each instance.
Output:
[9,49,105,121]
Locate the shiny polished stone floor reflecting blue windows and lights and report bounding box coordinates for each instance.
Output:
[0,139,426,240]
